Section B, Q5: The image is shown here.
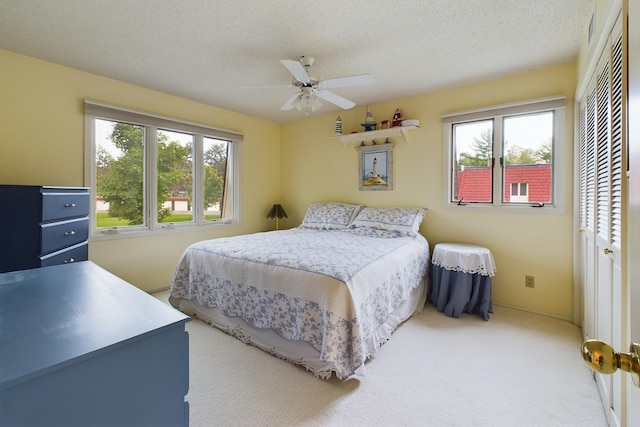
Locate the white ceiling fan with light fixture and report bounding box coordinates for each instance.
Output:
[240,56,373,114]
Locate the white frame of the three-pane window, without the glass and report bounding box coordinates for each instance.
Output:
[85,100,244,240]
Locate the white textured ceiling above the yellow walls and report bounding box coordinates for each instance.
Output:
[0,0,594,123]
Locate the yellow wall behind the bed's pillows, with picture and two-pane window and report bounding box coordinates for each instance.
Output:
[281,64,576,320]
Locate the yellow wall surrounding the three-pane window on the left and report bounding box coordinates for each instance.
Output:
[0,50,280,290]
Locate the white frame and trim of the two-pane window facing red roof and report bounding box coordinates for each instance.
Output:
[442,96,569,215]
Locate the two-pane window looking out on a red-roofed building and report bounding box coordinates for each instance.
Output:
[442,98,565,211]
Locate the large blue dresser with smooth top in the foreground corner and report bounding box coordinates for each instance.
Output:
[0,261,190,427]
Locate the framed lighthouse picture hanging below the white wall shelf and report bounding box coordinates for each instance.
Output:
[356,143,394,191]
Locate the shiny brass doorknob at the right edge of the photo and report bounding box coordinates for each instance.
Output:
[582,340,640,387]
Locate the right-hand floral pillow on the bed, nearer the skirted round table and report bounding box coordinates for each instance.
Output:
[349,208,427,236]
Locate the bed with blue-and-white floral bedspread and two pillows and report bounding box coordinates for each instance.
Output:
[169,203,429,379]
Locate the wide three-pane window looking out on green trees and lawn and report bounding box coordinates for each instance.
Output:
[85,102,242,236]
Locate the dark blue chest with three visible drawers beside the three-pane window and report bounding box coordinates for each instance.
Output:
[0,185,89,273]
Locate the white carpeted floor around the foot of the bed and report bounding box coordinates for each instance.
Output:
[155,291,607,427]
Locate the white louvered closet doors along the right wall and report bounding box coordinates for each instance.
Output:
[578,22,624,426]
